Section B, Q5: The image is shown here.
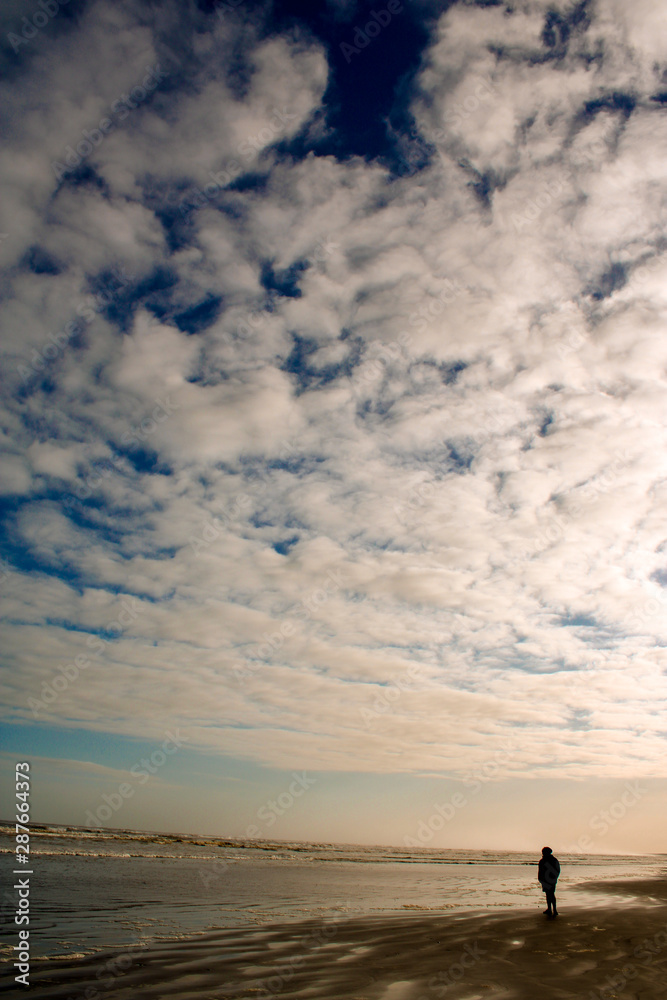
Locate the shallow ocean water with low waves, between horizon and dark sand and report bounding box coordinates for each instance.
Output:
[0,825,667,958]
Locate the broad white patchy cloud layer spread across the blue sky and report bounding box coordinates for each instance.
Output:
[3,3,667,792]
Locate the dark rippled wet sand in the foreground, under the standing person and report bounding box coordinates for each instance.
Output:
[3,880,667,1000]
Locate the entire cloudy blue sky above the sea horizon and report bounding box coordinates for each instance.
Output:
[0,0,667,853]
